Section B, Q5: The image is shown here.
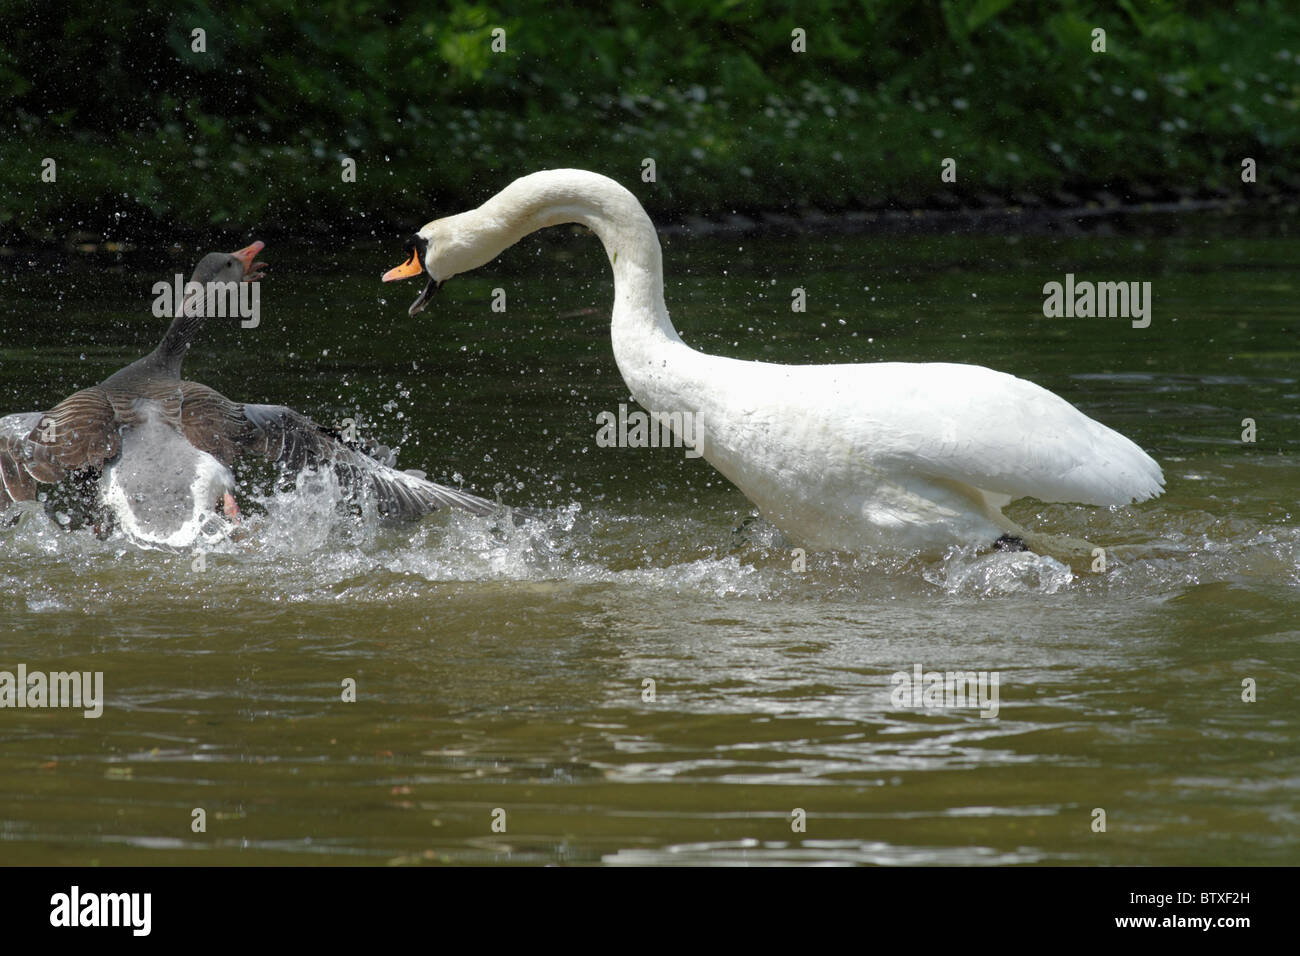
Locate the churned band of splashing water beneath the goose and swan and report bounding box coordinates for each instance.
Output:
[0,470,1300,607]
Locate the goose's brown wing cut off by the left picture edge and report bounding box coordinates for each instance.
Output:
[0,388,121,507]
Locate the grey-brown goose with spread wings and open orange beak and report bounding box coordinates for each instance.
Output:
[0,242,501,548]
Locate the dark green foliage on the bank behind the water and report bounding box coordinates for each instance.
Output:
[0,0,1300,239]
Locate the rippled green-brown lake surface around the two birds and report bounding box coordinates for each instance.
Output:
[0,215,1300,865]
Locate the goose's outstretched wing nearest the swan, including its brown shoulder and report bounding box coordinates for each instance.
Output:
[193,398,503,518]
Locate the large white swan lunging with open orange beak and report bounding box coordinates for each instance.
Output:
[384,169,1165,551]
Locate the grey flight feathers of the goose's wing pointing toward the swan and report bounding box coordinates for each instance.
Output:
[230,405,502,518]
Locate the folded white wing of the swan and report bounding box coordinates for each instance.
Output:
[857,363,1165,505]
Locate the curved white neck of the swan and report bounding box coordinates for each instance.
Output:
[467,169,681,356]
